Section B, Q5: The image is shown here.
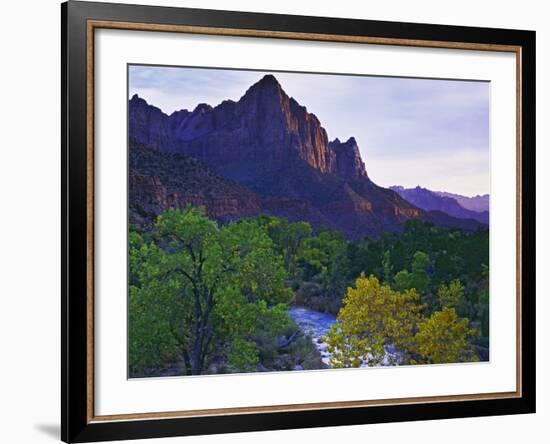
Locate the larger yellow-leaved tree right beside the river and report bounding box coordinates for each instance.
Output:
[327,274,422,368]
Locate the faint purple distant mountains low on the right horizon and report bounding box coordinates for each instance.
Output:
[390,186,489,224]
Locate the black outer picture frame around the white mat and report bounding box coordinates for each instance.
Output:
[61,1,536,442]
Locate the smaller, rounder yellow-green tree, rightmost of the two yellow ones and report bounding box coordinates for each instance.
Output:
[414,307,478,364]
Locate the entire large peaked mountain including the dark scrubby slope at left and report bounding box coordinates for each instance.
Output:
[128,75,485,239]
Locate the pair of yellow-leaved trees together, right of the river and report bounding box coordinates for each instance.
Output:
[326,275,484,368]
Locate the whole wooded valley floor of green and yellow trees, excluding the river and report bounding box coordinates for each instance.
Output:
[128,206,489,377]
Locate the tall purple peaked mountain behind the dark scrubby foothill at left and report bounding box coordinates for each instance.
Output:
[129,75,488,238]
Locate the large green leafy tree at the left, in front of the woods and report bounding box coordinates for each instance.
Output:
[129,208,291,375]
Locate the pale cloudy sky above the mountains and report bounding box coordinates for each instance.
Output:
[128,65,490,196]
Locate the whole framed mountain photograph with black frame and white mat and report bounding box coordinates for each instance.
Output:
[61,1,535,442]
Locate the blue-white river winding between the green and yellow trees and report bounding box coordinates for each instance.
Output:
[288,307,403,367]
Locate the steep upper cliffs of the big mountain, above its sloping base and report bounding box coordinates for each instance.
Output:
[130,75,366,181]
